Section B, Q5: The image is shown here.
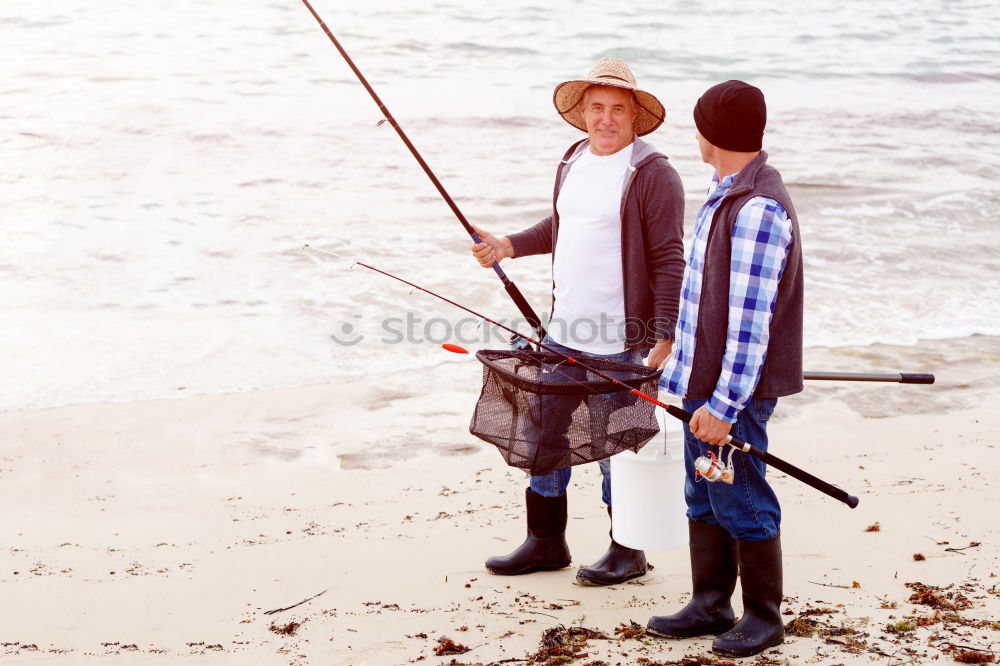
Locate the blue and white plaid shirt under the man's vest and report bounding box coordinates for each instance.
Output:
[660,174,792,423]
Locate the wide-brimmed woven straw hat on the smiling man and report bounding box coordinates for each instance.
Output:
[552,58,667,136]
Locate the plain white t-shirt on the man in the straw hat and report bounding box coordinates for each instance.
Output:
[548,143,633,354]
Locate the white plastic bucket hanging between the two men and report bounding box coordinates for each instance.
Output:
[611,409,688,550]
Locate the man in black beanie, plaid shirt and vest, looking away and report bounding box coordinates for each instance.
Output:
[649,81,802,657]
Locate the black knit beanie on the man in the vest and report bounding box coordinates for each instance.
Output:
[694,81,767,153]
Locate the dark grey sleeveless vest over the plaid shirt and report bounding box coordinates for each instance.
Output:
[685,151,803,400]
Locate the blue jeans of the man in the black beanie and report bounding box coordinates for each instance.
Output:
[684,398,781,541]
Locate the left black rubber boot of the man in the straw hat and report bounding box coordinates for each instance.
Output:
[486,488,570,576]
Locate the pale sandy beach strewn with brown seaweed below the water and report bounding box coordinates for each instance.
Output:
[0,336,1000,665]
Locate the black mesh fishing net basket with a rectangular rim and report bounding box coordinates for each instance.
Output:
[469,350,660,475]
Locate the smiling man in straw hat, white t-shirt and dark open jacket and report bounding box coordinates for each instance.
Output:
[472,58,684,585]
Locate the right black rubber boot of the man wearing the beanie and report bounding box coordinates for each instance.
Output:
[712,535,785,657]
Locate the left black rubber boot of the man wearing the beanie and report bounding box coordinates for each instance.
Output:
[646,520,736,638]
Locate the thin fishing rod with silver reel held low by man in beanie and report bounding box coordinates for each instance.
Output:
[354,261,858,509]
